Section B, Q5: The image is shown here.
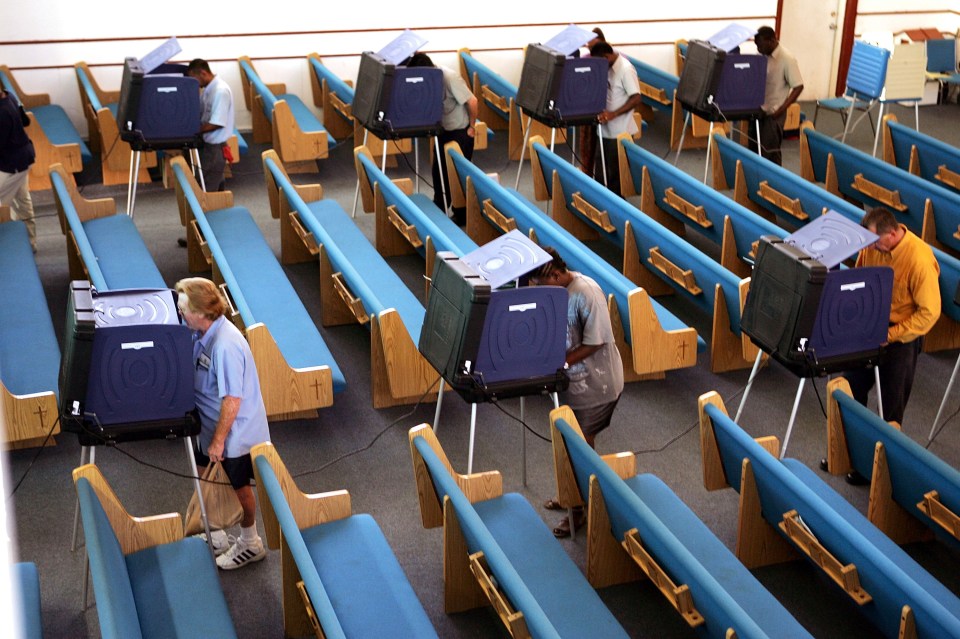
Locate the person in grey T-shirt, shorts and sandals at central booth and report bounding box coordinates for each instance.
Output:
[530,246,623,537]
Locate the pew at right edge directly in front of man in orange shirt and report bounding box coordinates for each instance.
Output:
[827,377,960,549]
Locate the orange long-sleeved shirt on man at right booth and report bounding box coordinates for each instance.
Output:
[857,224,940,342]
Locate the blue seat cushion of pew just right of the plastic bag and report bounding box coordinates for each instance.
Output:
[304,514,436,638]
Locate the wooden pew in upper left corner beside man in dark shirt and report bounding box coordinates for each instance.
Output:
[0,64,93,191]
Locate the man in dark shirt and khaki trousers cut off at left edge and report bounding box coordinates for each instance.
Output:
[0,90,37,253]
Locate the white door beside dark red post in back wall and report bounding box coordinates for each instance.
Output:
[780,0,846,100]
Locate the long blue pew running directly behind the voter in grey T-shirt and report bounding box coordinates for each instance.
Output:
[444,143,705,381]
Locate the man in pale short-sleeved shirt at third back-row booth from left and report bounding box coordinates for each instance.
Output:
[590,40,641,195]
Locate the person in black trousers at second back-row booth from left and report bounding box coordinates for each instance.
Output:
[407,53,479,226]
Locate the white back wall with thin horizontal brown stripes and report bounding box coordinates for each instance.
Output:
[0,0,960,136]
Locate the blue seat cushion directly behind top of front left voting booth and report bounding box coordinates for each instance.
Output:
[83,213,167,290]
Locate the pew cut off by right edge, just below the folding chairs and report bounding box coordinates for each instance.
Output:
[881,115,960,193]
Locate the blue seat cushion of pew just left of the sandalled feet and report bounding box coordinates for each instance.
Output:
[473,493,623,637]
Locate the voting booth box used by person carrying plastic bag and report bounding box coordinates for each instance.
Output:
[60,280,200,446]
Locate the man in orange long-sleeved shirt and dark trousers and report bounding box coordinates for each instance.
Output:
[844,207,940,424]
